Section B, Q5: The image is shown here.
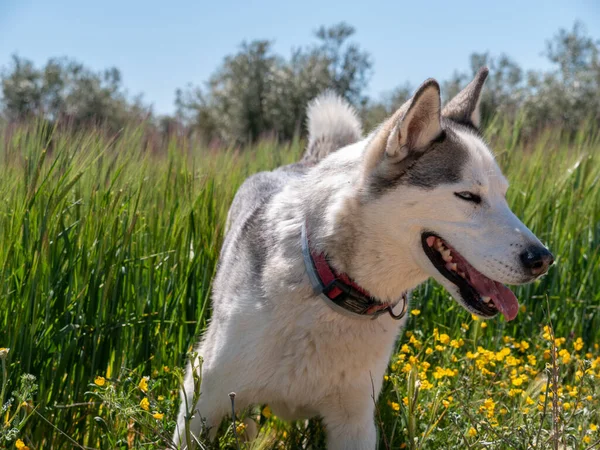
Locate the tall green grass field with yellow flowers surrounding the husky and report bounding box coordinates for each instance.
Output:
[0,120,600,450]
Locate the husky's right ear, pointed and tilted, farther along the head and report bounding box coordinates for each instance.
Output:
[442,67,489,128]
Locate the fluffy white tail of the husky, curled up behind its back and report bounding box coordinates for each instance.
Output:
[302,91,362,163]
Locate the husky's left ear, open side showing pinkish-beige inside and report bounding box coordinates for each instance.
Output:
[385,78,442,161]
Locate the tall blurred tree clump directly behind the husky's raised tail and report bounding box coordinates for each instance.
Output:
[176,23,371,144]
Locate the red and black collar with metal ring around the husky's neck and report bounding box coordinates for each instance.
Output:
[302,224,407,319]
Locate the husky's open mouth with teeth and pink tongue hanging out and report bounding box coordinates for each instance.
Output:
[421,232,519,320]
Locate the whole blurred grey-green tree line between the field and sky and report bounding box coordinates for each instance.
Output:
[0,22,600,145]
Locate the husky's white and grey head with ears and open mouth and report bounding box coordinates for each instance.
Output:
[362,68,553,320]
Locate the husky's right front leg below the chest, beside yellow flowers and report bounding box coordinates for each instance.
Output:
[321,398,377,450]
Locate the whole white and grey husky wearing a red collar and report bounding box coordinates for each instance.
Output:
[175,68,553,450]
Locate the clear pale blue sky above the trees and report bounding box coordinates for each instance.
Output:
[0,0,600,113]
